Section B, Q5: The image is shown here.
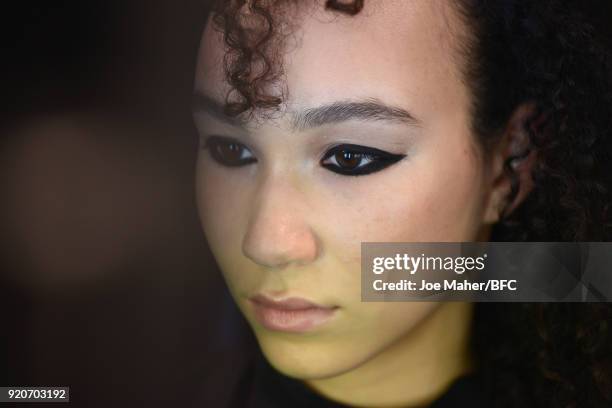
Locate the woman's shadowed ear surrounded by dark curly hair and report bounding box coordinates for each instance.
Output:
[484,103,537,224]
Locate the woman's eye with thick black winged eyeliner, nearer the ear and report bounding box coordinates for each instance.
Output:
[321,144,406,176]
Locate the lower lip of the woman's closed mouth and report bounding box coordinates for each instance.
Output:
[251,302,336,333]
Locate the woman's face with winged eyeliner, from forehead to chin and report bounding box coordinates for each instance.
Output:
[195,0,500,379]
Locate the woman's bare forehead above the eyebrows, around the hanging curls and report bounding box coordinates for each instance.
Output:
[196,0,465,122]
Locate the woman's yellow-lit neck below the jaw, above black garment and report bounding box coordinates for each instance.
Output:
[306,302,473,407]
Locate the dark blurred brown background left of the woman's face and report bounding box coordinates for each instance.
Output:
[0,0,252,407]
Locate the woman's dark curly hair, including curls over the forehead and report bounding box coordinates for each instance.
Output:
[207,0,612,408]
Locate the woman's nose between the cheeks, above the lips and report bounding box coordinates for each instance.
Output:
[242,175,319,268]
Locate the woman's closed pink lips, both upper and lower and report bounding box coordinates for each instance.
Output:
[249,295,337,333]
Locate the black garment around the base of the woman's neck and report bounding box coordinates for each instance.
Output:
[231,353,491,408]
